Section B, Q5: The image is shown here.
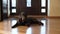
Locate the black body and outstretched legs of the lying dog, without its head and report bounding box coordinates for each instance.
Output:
[12,18,43,28]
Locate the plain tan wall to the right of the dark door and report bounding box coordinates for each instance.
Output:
[49,0,60,16]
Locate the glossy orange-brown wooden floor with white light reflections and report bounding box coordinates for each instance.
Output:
[0,18,60,34]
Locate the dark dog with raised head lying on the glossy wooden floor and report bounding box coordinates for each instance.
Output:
[12,12,43,28]
